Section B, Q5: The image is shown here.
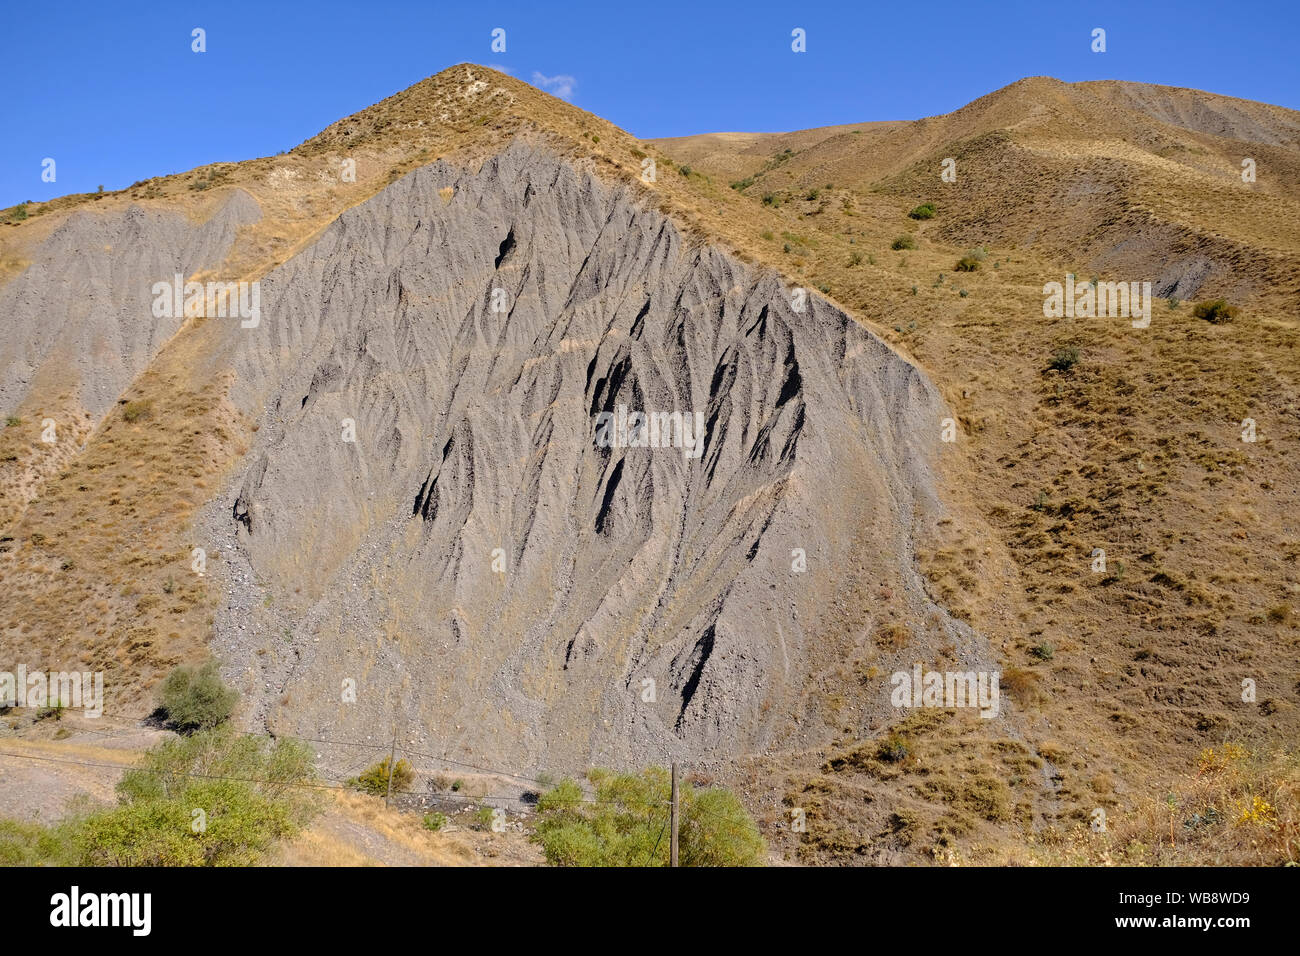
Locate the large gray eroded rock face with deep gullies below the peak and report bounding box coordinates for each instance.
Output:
[205,140,972,767]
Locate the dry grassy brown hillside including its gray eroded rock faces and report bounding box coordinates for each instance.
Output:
[0,65,1300,862]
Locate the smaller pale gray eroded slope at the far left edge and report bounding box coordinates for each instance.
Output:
[0,191,261,418]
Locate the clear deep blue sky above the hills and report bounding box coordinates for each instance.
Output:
[0,0,1300,207]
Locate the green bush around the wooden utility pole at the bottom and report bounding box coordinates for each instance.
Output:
[533,767,767,866]
